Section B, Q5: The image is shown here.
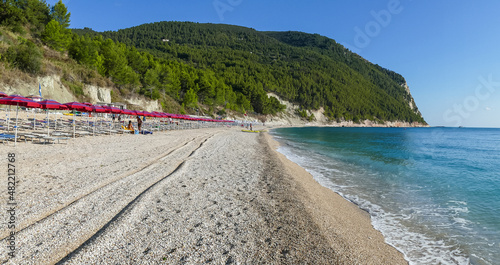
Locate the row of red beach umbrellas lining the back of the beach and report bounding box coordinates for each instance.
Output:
[0,92,234,145]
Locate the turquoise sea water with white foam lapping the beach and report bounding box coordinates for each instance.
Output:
[272,127,500,264]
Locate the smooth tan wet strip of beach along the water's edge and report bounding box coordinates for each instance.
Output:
[264,133,408,264]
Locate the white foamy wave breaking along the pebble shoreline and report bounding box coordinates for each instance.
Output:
[277,138,472,265]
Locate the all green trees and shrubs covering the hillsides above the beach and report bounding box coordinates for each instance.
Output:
[0,0,425,122]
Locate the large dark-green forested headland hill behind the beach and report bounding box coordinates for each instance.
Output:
[74,22,423,122]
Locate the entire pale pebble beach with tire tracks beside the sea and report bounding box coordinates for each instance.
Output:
[0,128,406,264]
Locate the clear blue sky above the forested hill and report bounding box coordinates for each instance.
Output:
[47,0,500,127]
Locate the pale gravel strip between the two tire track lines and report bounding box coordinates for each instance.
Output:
[0,134,217,264]
